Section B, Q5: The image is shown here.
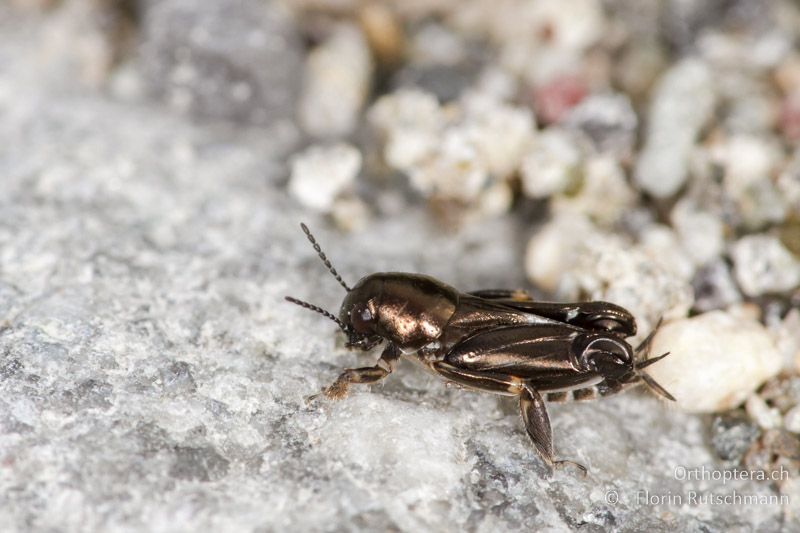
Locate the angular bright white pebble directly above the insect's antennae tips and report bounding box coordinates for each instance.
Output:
[289,143,361,212]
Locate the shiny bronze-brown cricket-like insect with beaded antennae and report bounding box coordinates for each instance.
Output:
[286,224,674,474]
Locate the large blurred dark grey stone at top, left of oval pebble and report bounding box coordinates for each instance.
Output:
[139,0,302,127]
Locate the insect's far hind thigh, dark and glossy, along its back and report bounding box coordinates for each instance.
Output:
[468,289,636,337]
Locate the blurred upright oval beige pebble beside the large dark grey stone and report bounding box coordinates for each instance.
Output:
[299,25,372,137]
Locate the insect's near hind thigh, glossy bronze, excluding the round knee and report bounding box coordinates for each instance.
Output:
[444,323,601,392]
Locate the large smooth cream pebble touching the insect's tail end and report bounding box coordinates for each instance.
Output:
[647,311,782,413]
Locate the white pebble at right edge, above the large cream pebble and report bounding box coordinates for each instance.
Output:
[731,235,800,296]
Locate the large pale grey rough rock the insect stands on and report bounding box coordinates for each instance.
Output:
[0,2,800,533]
